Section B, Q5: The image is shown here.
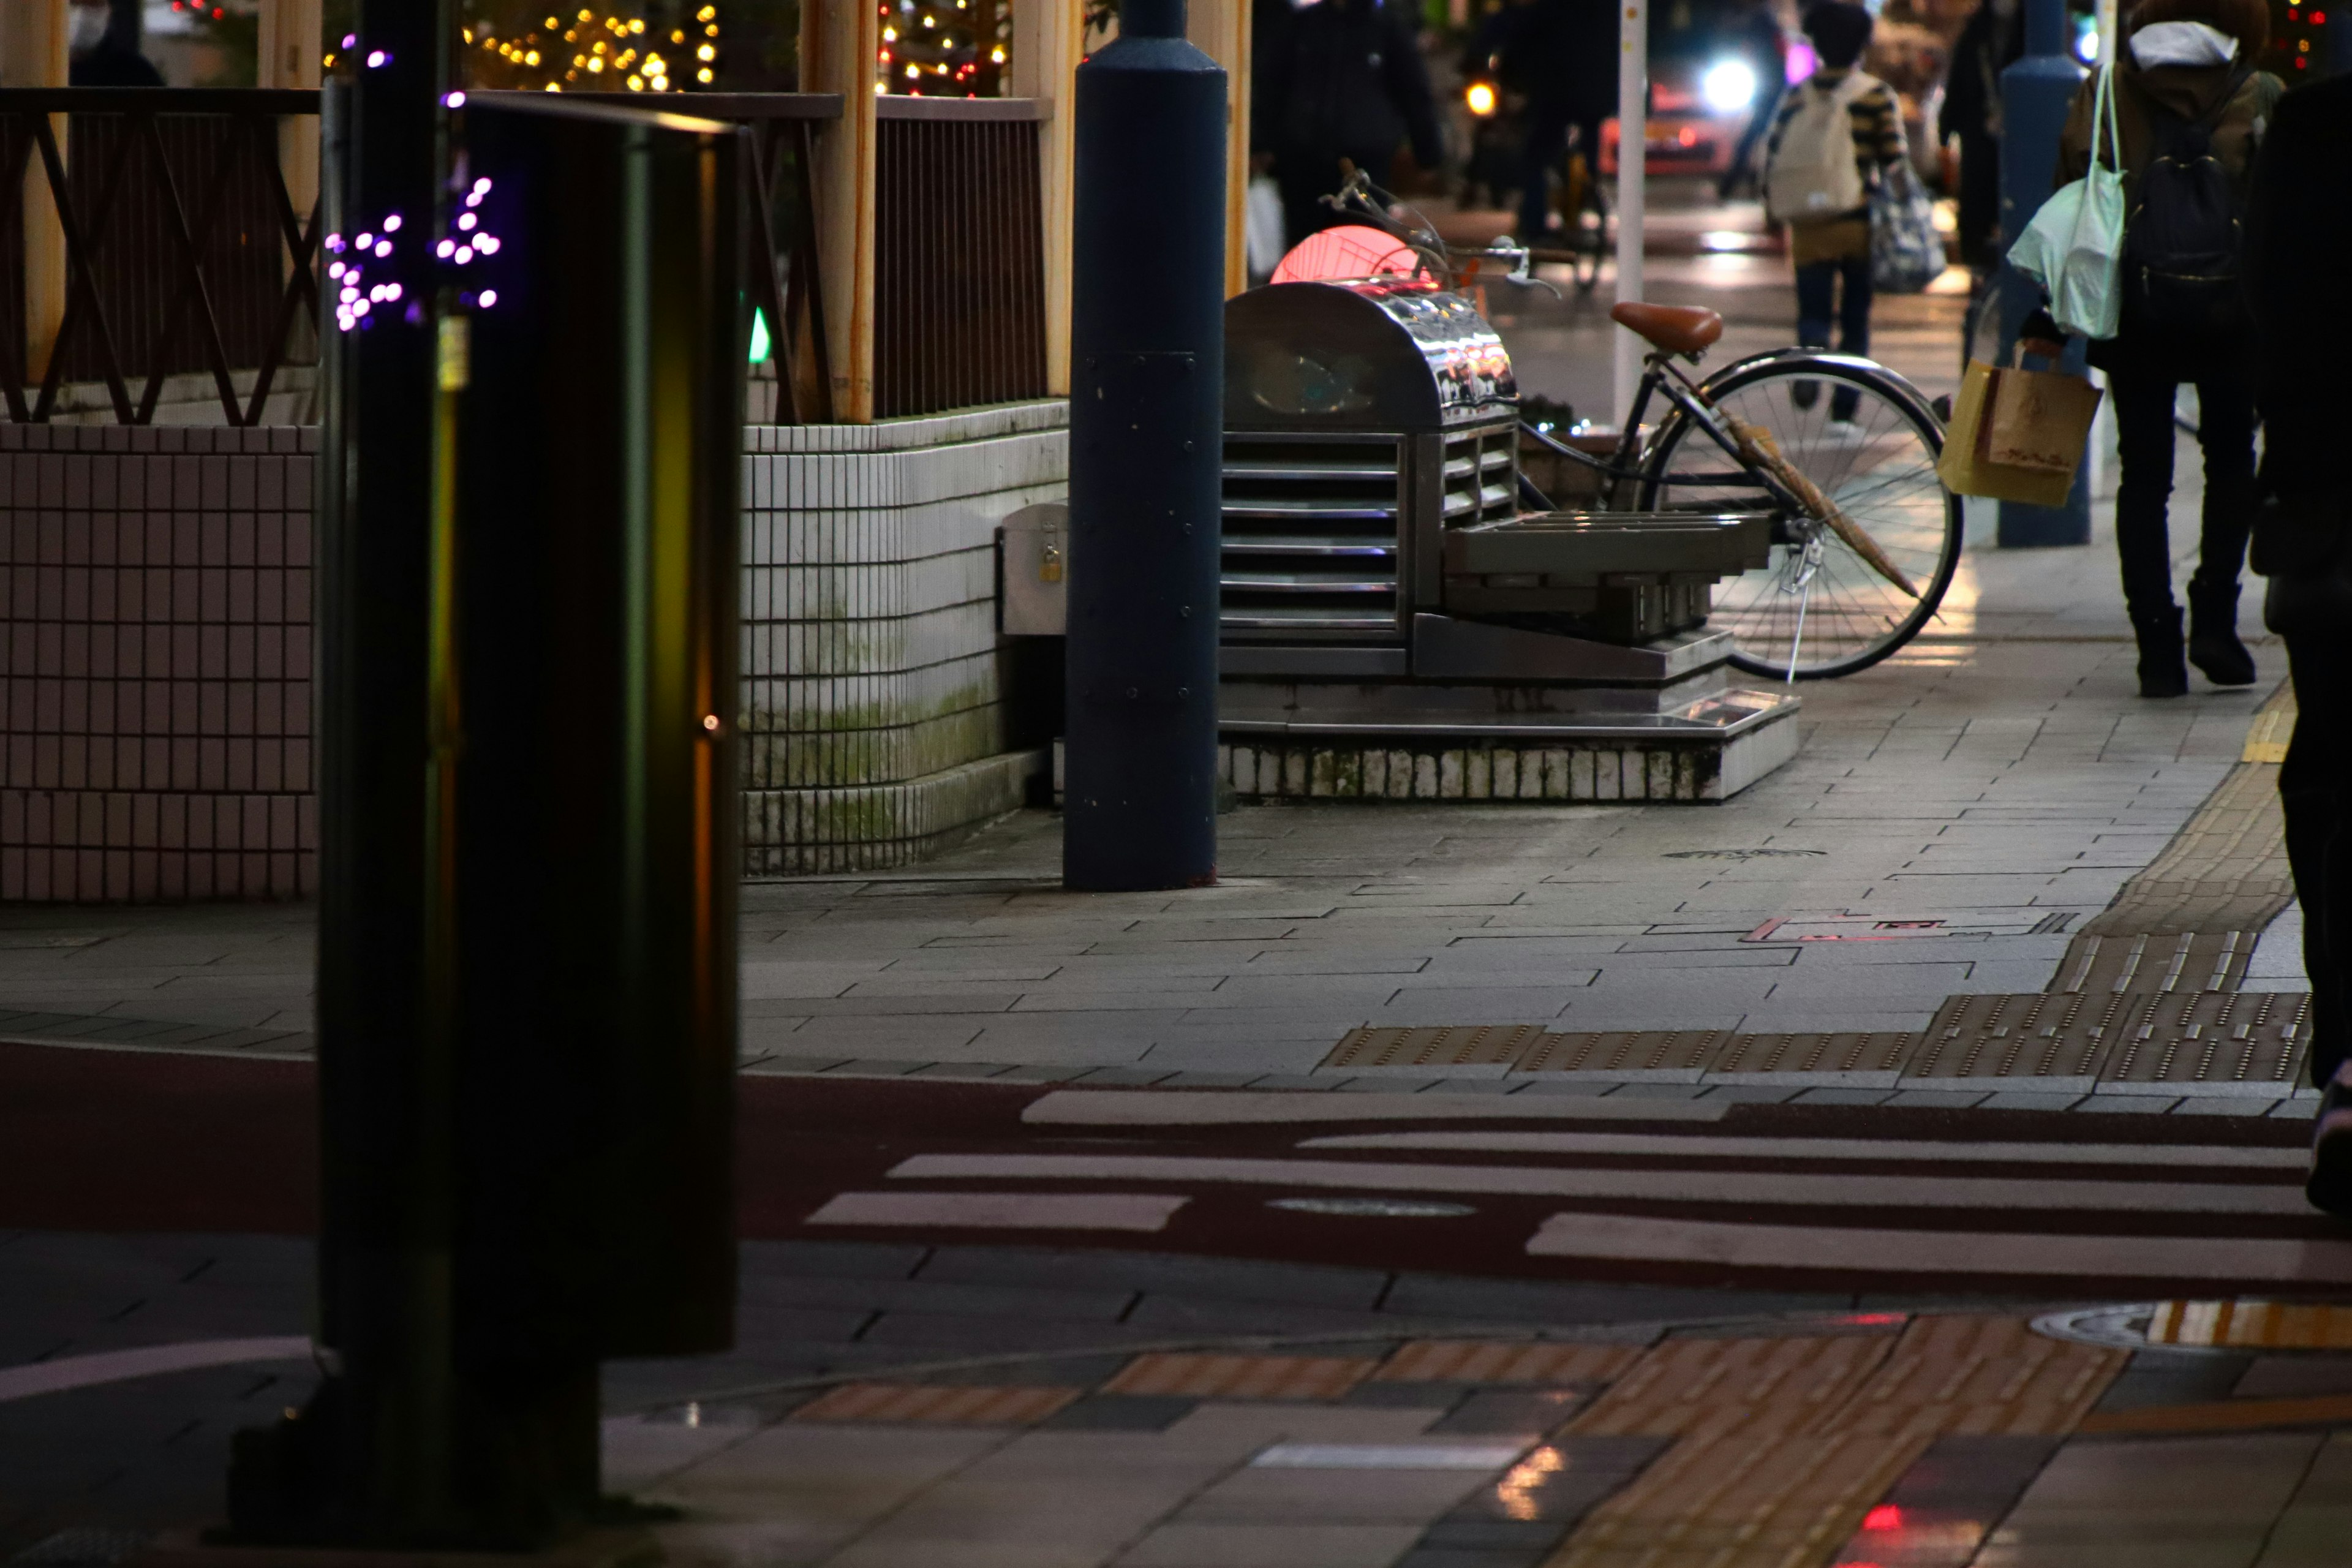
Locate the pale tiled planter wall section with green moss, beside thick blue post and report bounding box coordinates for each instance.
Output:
[741,402,1070,875]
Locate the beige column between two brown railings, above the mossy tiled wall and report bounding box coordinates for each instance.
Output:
[800,0,884,426]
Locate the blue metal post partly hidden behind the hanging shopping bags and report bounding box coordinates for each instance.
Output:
[1994,0,2091,545]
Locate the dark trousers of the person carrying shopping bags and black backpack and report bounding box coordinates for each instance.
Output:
[2108,369,2258,620]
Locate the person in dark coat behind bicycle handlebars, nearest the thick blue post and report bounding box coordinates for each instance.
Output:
[1251,0,1444,244]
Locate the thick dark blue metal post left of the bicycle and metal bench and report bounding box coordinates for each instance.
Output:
[1061,0,1227,891]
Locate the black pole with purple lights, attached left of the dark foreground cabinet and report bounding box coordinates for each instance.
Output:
[315,0,456,1542]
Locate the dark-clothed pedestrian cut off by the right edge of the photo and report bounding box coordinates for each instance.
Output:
[2244,75,2352,1218]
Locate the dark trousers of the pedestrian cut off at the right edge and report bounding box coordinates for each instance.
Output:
[2279,616,2352,1086]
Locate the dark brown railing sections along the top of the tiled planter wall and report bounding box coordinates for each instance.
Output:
[0,87,1047,426]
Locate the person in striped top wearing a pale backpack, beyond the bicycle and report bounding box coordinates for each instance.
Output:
[1764,0,1910,426]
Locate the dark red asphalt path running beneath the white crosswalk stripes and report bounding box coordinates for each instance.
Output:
[0,1046,2352,1295]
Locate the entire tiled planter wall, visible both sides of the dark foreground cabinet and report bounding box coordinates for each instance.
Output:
[0,402,1068,903]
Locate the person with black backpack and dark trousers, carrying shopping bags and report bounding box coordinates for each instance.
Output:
[2021,0,2282,698]
